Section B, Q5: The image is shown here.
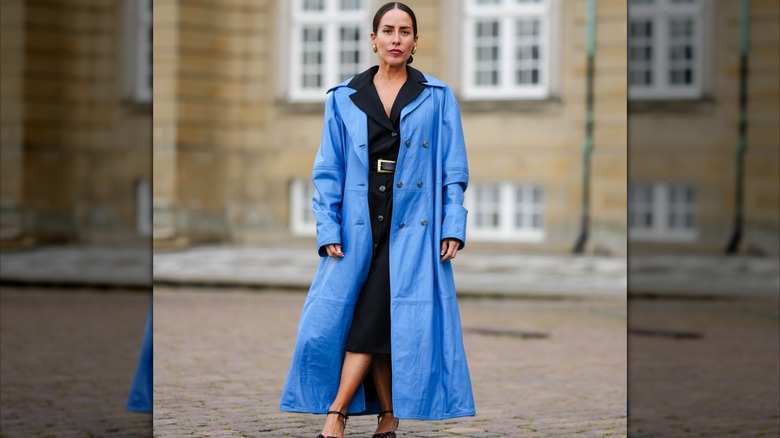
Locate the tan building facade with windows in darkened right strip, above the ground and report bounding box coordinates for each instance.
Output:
[628,0,780,256]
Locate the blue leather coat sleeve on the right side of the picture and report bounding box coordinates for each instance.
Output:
[441,89,469,250]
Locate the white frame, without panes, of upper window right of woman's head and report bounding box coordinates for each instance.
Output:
[461,0,558,100]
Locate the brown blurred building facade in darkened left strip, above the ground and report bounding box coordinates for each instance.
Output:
[0,0,152,248]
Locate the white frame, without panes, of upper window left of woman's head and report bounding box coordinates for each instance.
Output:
[289,0,371,102]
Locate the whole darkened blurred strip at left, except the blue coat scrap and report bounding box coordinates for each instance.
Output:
[0,0,152,437]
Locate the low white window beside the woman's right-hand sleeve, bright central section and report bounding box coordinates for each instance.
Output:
[465,182,544,241]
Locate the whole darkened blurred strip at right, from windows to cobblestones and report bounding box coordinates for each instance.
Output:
[626,0,780,436]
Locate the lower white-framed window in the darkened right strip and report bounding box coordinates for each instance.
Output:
[628,183,697,240]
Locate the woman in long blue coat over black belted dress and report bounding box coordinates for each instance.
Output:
[281,2,475,437]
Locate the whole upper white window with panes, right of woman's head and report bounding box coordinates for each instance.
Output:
[463,0,552,99]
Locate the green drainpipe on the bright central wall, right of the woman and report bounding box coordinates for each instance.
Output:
[572,0,596,254]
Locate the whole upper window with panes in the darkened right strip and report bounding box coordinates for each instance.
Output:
[628,0,704,99]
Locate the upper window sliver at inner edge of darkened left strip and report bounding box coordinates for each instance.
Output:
[124,0,153,103]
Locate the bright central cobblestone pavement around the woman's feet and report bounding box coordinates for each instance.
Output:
[154,287,627,437]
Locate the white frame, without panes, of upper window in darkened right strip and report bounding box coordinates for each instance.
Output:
[628,0,710,100]
